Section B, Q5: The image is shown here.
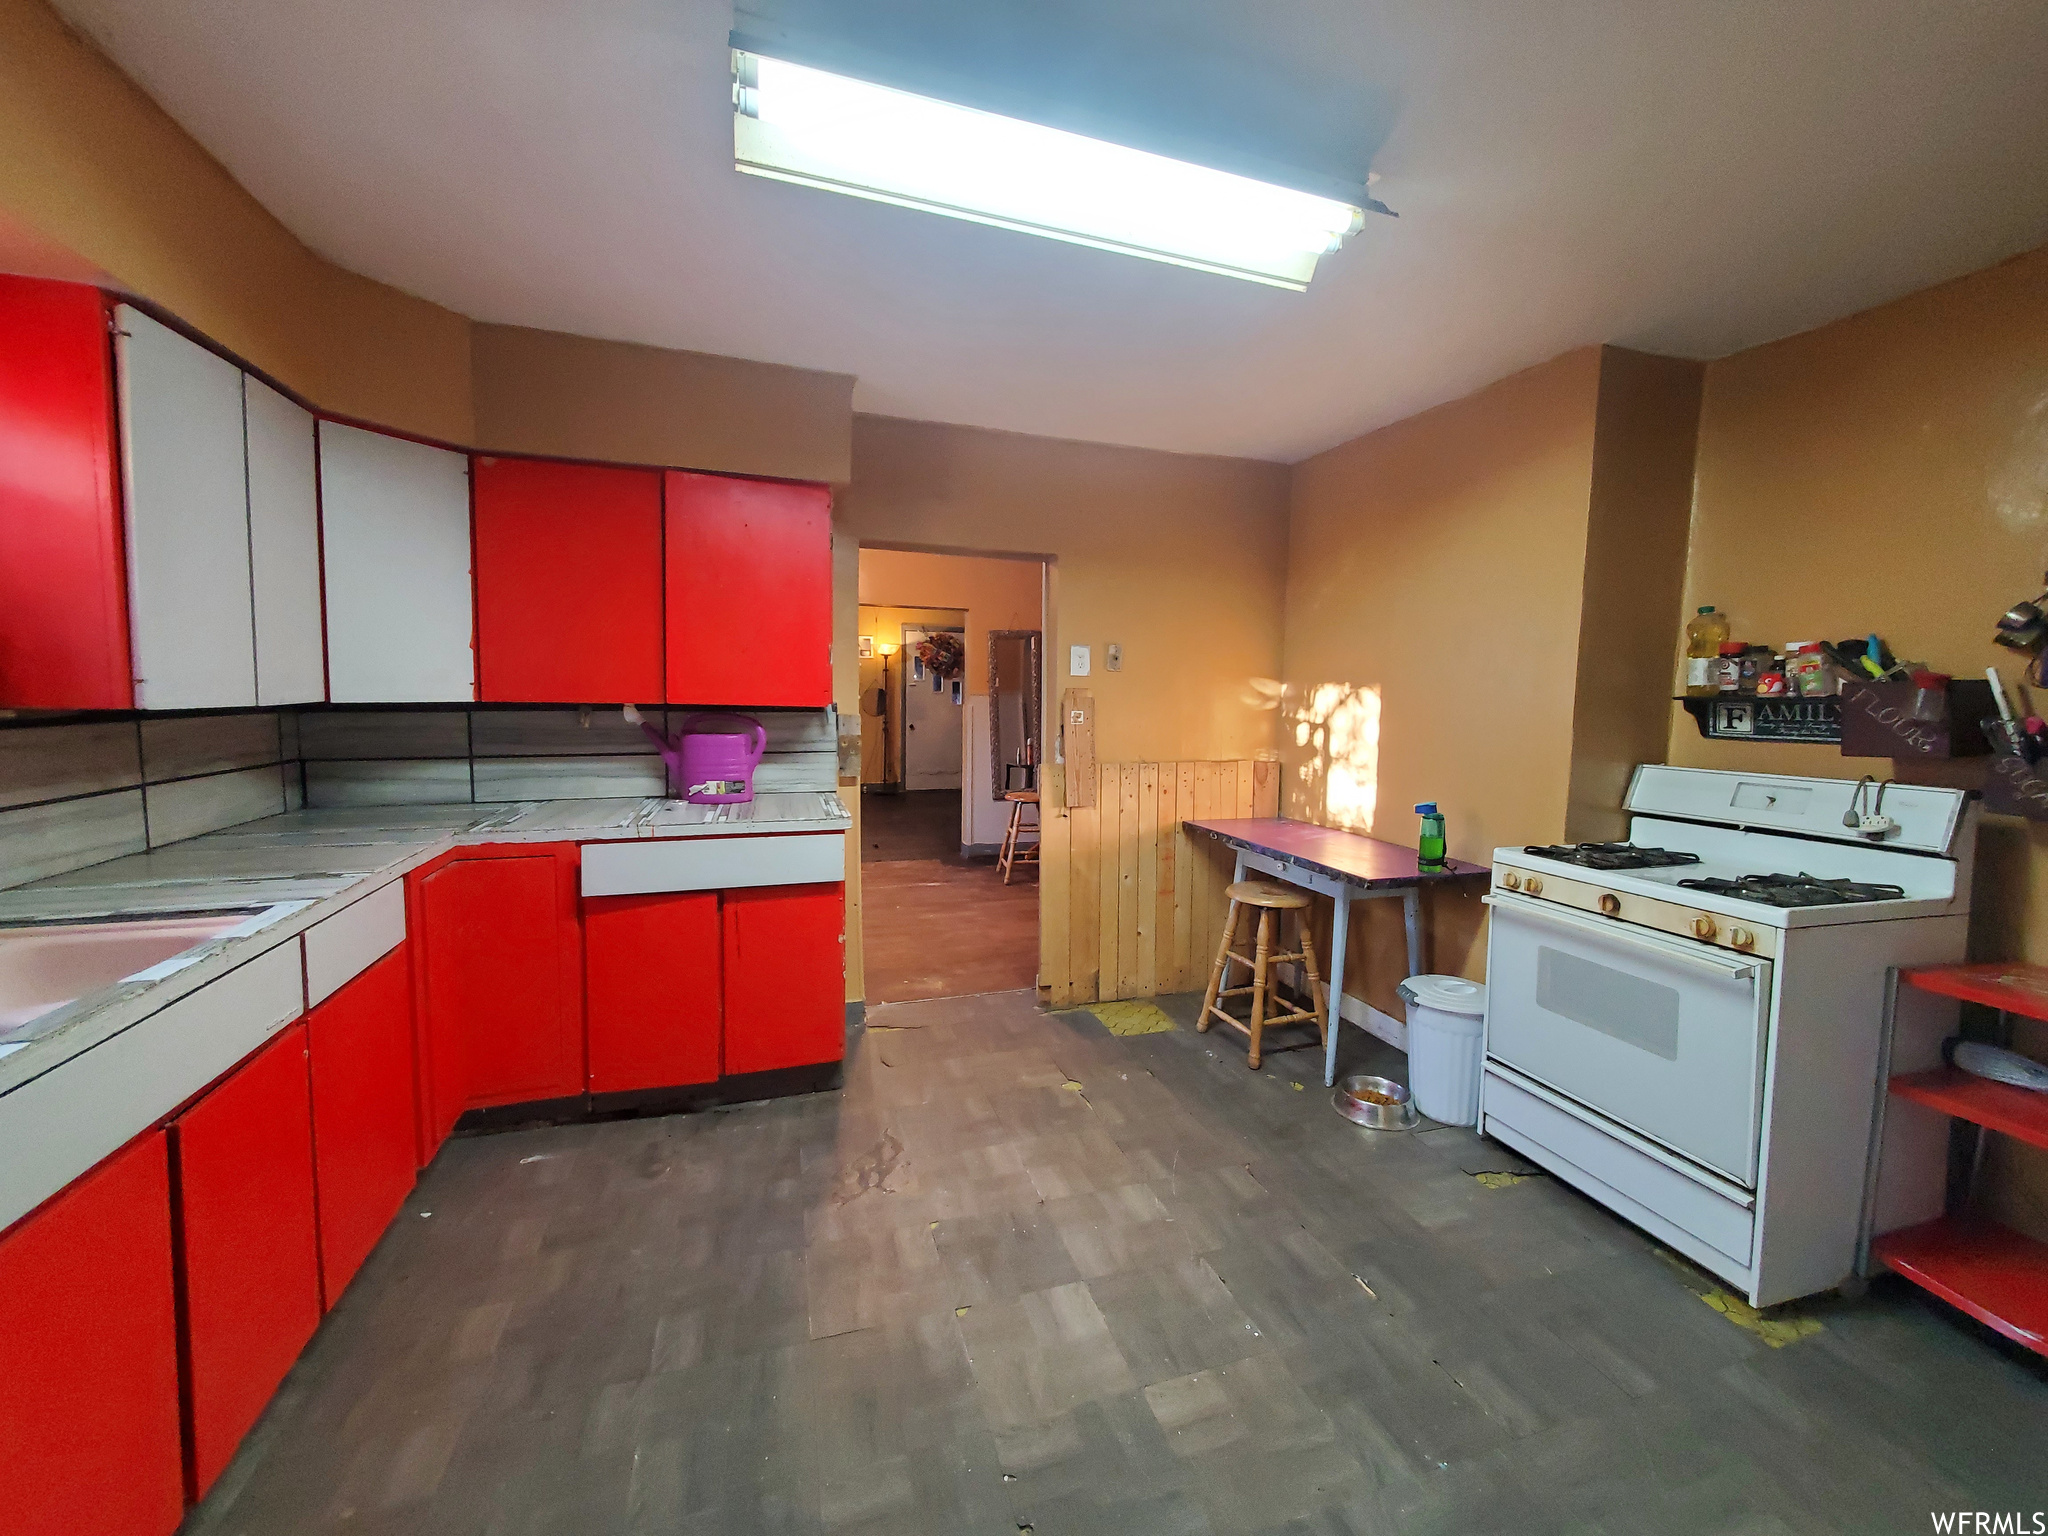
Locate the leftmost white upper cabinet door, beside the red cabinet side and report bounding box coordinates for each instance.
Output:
[115,305,256,709]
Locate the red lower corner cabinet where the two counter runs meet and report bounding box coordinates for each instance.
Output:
[414,844,584,1145]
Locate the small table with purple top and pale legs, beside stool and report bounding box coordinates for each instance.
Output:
[1182,815,1487,1087]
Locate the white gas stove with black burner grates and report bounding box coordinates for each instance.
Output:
[1481,766,1976,1307]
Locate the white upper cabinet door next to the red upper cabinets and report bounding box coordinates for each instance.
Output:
[319,422,477,705]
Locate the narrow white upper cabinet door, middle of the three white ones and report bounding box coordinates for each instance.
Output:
[242,375,328,705]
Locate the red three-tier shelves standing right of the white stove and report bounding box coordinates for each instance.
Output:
[1870,965,2048,1356]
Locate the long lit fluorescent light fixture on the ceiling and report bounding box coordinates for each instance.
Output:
[733,49,1364,293]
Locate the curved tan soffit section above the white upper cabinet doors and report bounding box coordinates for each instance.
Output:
[0,0,471,442]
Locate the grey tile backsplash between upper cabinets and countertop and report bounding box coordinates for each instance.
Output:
[0,705,838,889]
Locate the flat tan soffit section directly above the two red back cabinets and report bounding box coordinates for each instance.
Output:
[473,324,854,483]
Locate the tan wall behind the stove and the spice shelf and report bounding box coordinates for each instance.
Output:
[1667,250,2048,1237]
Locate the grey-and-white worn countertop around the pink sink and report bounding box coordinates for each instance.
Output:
[0,791,852,1096]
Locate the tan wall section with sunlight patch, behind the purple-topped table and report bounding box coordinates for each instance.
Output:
[1280,348,1599,1016]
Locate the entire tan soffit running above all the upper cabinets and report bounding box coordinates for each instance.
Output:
[0,0,854,483]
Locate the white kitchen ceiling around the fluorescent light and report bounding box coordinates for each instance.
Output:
[57,0,2048,461]
